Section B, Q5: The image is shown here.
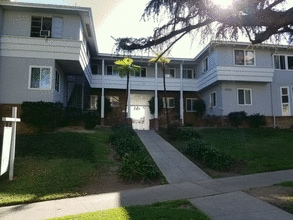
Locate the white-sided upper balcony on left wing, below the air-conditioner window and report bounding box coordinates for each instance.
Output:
[0,35,92,80]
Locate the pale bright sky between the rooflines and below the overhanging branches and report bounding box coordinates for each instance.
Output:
[15,0,292,58]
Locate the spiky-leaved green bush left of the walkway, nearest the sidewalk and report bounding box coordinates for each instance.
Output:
[117,152,160,182]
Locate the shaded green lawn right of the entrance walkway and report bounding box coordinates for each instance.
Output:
[162,128,293,177]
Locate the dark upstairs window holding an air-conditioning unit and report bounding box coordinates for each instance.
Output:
[31,16,52,37]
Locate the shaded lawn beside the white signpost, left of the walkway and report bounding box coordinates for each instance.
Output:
[0,129,111,205]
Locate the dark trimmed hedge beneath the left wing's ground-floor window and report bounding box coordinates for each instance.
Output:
[20,101,64,131]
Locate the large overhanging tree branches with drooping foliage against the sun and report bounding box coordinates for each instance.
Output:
[116,0,293,51]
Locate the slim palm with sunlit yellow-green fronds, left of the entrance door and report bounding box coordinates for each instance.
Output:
[114,57,140,120]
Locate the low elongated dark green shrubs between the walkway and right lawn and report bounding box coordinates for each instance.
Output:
[184,138,235,170]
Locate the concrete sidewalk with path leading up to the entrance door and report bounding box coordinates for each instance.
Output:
[0,131,293,220]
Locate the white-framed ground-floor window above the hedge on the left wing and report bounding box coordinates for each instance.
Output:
[29,67,51,90]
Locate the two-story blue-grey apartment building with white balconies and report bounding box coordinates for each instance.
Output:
[0,2,293,129]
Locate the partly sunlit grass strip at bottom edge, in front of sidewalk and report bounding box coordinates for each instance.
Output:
[50,200,209,220]
